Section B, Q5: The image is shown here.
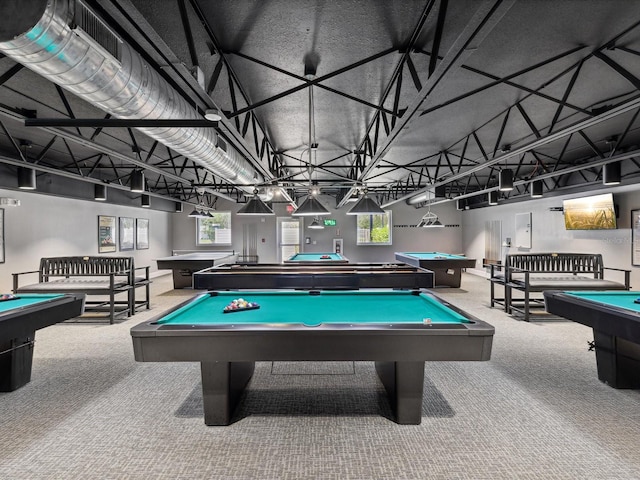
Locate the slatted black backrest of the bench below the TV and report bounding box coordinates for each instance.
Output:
[505,253,604,278]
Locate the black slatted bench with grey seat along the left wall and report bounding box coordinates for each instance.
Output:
[13,257,151,324]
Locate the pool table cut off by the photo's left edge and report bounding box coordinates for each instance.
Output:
[0,293,84,392]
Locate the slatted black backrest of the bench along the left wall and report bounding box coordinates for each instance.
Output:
[39,257,133,282]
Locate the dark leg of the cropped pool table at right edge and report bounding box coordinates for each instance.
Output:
[593,330,640,388]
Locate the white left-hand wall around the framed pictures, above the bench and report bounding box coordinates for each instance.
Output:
[0,189,174,292]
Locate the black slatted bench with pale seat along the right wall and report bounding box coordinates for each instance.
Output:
[489,253,631,321]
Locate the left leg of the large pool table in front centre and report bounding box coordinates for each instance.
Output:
[200,362,255,425]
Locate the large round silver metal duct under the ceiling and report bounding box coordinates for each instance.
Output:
[0,0,256,185]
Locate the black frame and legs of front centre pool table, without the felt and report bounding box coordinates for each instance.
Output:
[131,292,494,425]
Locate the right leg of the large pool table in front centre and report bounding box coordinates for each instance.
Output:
[376,362,424,425]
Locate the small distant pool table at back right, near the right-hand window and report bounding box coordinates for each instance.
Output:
[395,252,476,288]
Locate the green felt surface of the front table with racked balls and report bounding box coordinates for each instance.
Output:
[158,291,469,326]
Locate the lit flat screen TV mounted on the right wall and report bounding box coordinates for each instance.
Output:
[562,193,616,230]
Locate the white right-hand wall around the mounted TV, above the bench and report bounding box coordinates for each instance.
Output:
[462,188,640,288]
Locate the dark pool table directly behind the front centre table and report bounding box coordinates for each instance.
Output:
[193,263,433,290]
